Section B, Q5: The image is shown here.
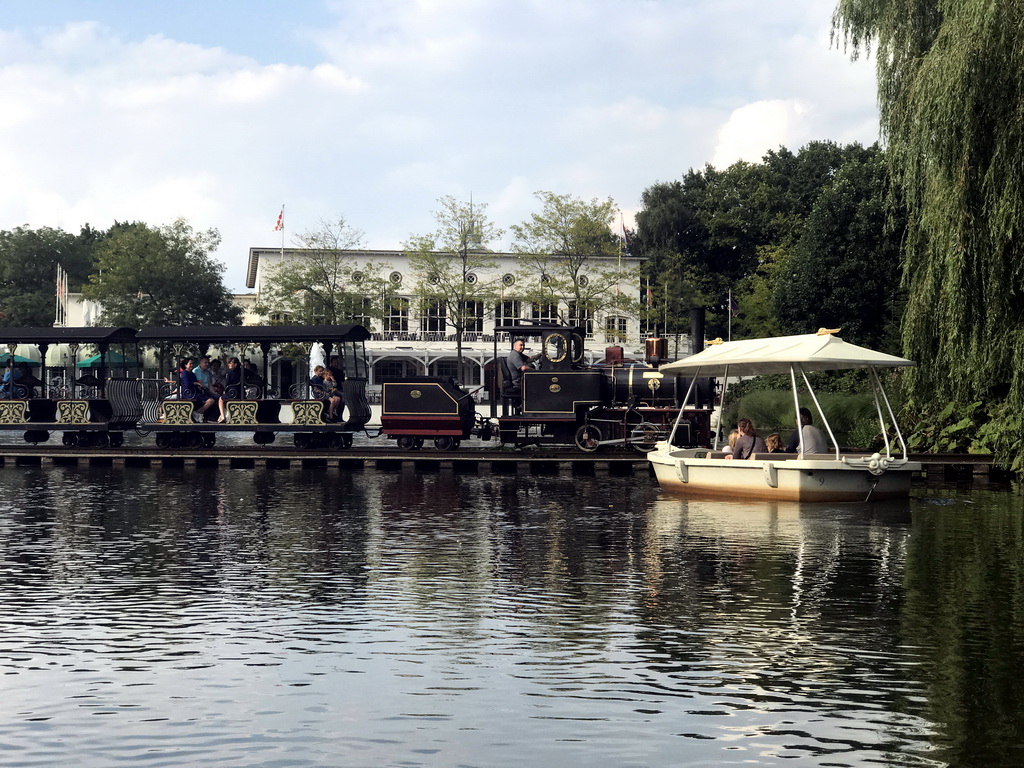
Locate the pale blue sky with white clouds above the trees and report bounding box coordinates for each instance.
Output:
[0,0,879,292]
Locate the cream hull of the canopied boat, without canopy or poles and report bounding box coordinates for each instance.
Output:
[648,451,922,502]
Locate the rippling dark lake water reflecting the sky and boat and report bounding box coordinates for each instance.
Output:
[0,468,1024,768]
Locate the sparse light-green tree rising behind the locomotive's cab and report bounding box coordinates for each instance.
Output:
[511,191,640,335]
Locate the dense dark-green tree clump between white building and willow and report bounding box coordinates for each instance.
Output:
[634,141,898,338]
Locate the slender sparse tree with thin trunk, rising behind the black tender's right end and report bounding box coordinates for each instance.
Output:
[404,196,503,381]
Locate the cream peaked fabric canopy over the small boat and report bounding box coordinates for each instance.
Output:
[660,332,915,376]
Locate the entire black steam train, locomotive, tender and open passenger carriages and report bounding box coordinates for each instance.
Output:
[0,324,713,452]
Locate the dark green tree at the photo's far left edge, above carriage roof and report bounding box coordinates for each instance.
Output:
[0,224,102,326]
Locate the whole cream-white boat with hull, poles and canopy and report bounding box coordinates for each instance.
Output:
[647,329,922,502]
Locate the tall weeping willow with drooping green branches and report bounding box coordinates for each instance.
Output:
[833,0,1024,419]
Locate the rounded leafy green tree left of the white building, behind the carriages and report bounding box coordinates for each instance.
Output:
[82,219,242,328]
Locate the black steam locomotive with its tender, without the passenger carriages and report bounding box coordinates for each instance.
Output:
[381,323,714,452]
